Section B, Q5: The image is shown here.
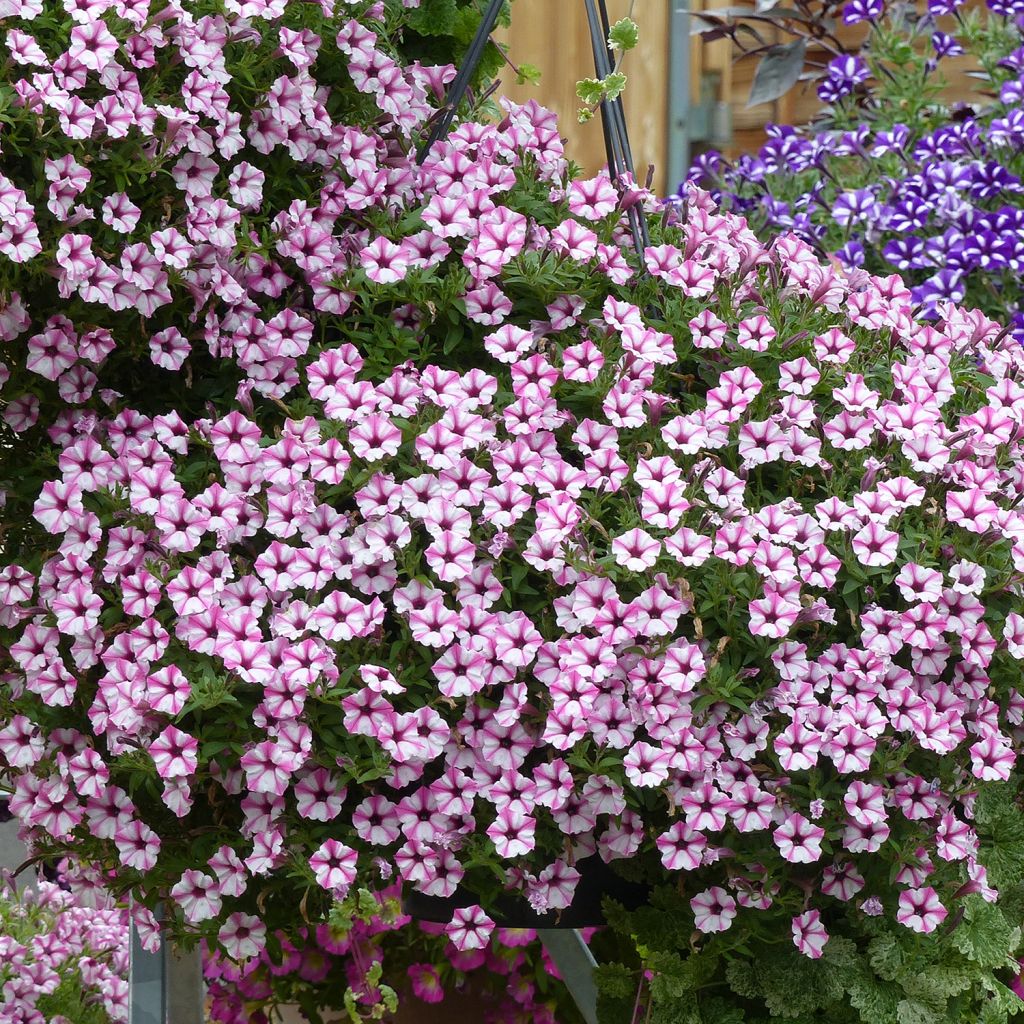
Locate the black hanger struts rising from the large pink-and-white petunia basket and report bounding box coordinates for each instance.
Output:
[416,0,650,258]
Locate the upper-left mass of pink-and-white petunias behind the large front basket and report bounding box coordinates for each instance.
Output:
[0,0,465,435]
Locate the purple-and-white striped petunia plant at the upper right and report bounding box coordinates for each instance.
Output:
[691,0,1024,340]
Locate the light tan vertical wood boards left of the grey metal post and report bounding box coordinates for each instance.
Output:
[499,0,670,188]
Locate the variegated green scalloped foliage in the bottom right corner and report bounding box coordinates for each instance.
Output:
[598,883,1024,1024]
